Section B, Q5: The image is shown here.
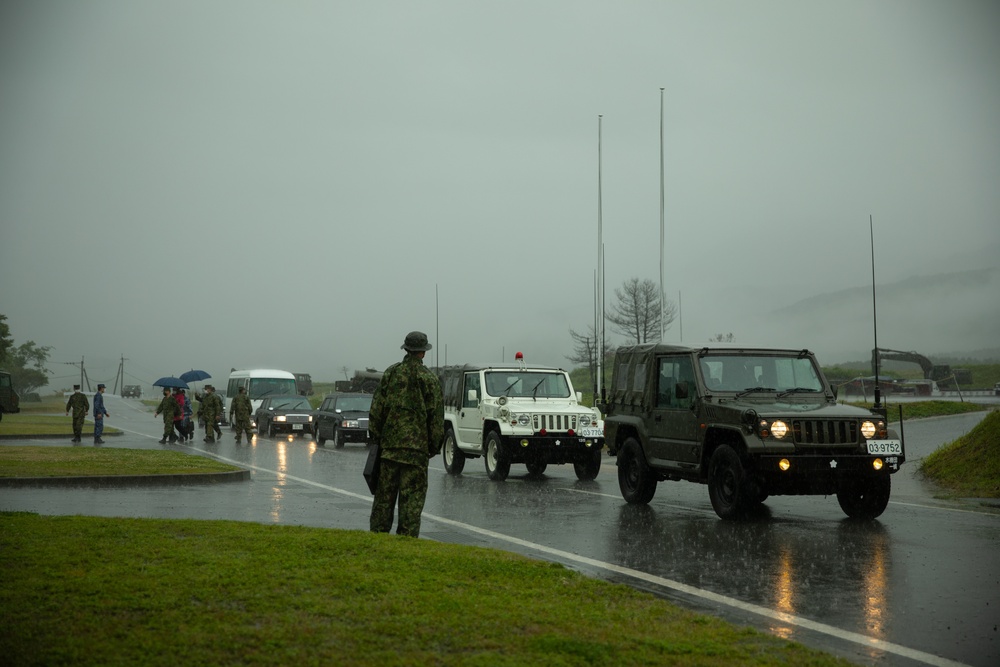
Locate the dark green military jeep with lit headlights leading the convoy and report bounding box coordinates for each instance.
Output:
[604,344,905,519]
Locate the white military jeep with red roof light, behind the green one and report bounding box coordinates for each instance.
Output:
[437,357,604,481]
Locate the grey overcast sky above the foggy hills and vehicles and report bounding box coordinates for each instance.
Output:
[0,0,1000,388]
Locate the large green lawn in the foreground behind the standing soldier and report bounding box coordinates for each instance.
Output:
[0,513,850,667]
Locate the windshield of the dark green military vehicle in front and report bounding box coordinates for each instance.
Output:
[699,354,823,393]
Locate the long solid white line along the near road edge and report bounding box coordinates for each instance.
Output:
[184,445,968,667]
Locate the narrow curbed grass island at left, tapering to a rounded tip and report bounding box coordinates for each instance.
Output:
[0,446,241,477]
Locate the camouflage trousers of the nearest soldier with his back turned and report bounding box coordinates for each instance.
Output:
[369,459,427,537]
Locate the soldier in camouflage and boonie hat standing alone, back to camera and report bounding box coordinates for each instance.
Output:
[368,331,444,537]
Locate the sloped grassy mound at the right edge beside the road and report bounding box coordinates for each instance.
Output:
[920,410,1000,498]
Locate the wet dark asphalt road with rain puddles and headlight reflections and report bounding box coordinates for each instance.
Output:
[0,397,1000,667]
